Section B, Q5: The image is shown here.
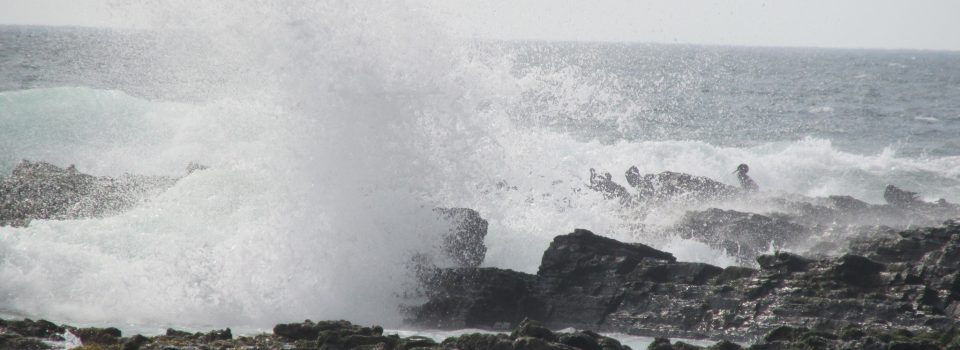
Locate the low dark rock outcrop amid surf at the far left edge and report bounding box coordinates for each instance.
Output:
[0,160,176,226]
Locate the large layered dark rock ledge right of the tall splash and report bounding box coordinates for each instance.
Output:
[406,221,960,341]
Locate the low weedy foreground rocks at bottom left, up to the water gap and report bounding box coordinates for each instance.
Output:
[0,320,631,350]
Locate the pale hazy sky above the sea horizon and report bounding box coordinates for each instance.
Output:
[0,0,960,51]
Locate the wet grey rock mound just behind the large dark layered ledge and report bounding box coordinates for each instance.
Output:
[673,208,810,264]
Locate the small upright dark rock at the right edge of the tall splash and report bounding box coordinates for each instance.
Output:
[434,208,487,267]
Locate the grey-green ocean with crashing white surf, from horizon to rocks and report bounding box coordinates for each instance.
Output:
[0,4,960,334]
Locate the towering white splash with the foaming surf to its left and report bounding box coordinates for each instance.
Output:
[0,2,516,325]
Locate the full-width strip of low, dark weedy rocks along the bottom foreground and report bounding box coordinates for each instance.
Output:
[0,319,960,350]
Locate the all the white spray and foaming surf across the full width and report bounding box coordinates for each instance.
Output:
[0,1,960,327]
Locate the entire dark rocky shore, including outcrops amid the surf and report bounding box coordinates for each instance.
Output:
[0,161,960,350]
